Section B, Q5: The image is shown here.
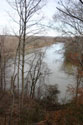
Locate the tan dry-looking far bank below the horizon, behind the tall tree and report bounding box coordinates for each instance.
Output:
[0,36,54,52]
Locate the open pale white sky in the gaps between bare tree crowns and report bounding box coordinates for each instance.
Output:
[0,0,58,36]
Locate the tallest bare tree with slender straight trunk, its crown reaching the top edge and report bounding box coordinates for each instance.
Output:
[8,0,45,105]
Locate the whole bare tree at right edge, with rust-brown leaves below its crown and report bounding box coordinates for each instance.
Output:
[54,0,83,103]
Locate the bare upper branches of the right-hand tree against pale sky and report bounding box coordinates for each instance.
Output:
[54,0,83,35]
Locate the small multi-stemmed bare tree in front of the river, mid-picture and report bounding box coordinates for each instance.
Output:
[26,50,50,98]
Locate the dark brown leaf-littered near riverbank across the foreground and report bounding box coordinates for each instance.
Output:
[0,91,83,125]
